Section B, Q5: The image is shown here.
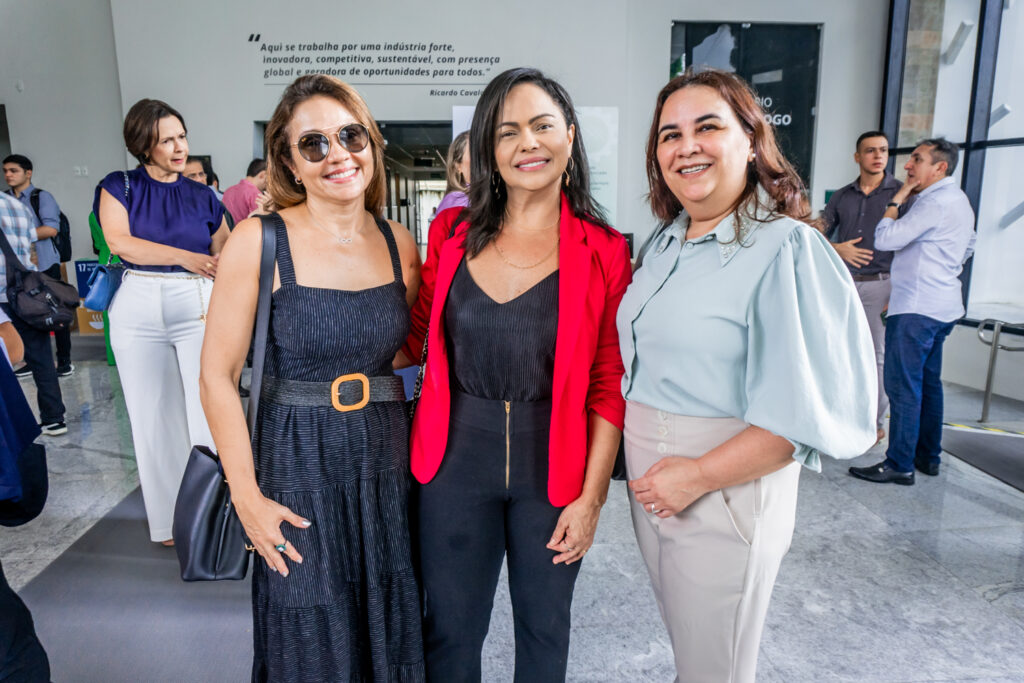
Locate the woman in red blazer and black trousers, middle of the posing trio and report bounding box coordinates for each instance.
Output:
[403,69,630,681]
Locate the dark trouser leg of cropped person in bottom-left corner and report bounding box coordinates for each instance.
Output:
[0,565,50,683]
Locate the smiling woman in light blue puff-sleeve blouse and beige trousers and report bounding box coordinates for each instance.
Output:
[617,71,877,681]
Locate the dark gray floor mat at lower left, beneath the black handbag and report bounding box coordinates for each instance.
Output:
[20,488,252,683]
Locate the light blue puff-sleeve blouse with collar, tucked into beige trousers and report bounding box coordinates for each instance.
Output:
[616,200,878,471]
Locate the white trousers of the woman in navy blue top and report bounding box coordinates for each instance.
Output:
[108,270,213,542]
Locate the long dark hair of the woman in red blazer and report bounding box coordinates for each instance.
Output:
[465,68,608,257]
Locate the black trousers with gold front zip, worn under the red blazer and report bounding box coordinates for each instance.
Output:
[417,392,580,683]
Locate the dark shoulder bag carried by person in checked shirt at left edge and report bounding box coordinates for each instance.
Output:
[0,232,79,332]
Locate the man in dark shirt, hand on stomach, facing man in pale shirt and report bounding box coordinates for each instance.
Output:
[821,130,903,441]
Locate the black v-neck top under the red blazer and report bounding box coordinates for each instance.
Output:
[444,259,558,401]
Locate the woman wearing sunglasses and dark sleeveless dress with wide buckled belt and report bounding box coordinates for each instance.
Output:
[202,75,424,682]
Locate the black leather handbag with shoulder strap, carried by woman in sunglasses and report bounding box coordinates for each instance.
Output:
[172,214,281,581]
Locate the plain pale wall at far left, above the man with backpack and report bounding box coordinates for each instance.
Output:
[0,0,125,258]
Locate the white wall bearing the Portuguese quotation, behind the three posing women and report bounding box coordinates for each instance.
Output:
[111,0,888,245]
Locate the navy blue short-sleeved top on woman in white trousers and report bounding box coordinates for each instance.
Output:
[92,167,224,272]
